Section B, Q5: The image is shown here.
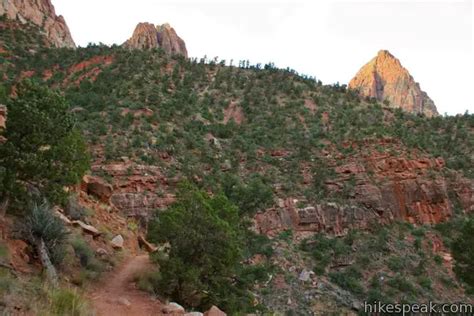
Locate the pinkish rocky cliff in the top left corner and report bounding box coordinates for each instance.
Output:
[0,0,76,48]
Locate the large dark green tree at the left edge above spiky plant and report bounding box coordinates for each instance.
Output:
[0,81,89,207]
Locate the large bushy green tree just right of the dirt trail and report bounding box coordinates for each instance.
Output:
[148,183,258,312]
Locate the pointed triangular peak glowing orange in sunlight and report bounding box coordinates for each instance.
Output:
[349,50,438,117]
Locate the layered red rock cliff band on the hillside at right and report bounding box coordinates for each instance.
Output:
[255,139,474,235]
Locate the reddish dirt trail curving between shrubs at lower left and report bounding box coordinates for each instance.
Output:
[89,255,161,316]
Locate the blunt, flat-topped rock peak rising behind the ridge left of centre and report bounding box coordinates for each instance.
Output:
[124,23,188,58]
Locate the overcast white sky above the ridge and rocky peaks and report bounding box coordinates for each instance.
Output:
[53,0,474,114]
